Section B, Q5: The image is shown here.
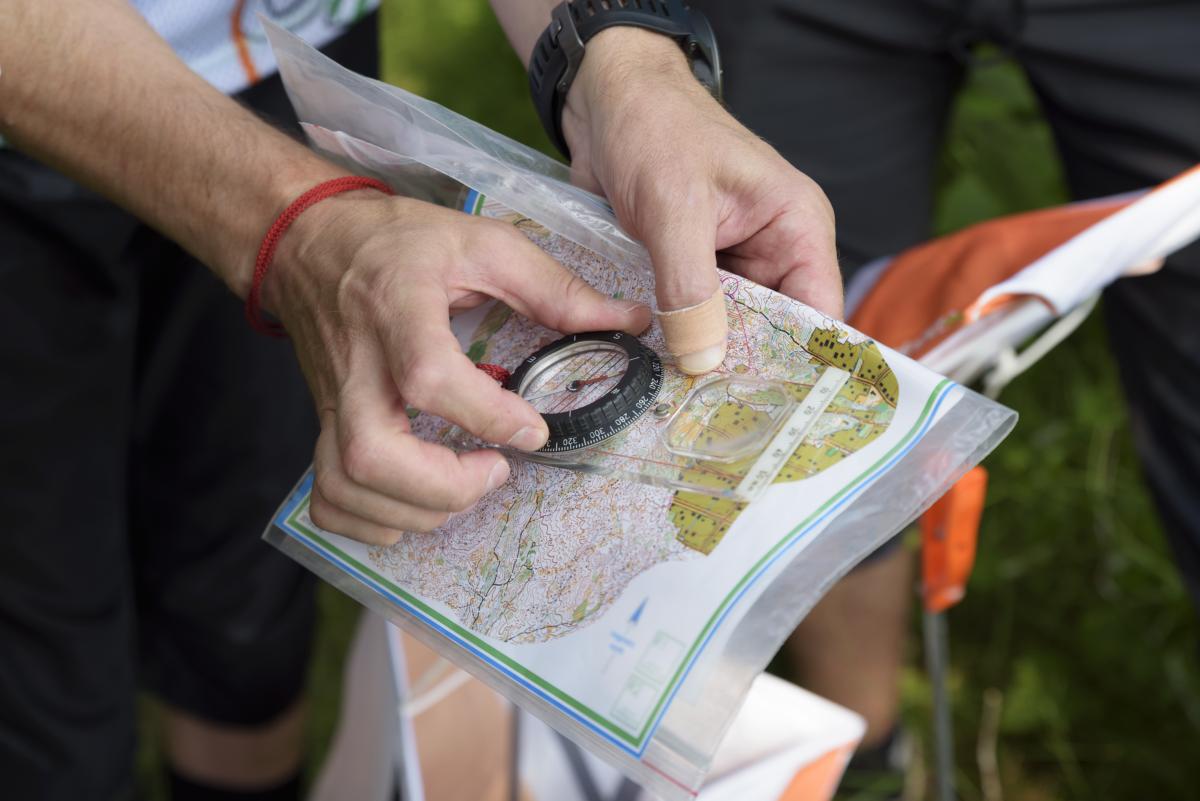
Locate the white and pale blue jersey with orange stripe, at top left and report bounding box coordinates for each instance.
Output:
[132,0,379,94]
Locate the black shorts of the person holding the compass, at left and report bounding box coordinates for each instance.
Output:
[0,14,378,800]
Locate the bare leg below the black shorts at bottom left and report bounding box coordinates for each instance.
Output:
[163,703,305,791]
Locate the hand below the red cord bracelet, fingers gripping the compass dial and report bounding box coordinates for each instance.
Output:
[263,192,649,544]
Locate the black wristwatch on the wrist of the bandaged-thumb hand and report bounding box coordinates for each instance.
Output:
[529,0,721,161]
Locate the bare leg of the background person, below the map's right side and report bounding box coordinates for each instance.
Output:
[784,546,913,747]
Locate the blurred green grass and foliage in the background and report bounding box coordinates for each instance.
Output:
[143,0,1200,801]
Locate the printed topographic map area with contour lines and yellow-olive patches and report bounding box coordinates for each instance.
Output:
[370,203,899,643]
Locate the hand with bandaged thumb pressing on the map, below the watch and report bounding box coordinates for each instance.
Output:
[563,28,842,373]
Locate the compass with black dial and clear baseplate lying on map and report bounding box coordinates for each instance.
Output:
[480,331,850,501]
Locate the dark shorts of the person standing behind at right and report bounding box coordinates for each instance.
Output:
[692,0,1200,587]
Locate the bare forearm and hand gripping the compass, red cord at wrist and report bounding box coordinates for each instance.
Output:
[0,0,649,543]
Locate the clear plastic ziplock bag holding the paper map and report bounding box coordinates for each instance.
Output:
[265,26,1016,799]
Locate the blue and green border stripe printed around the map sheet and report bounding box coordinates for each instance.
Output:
[274,379,958,758]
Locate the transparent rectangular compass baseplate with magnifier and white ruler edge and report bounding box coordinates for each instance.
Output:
[446,369,846,501]
